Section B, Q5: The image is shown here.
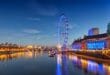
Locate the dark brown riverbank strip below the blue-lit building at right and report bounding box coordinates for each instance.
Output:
[59,51,110,64]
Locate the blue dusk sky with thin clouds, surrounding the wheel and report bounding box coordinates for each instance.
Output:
[0,0,110,45]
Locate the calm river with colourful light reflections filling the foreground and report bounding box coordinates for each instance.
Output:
[0,51,110,75]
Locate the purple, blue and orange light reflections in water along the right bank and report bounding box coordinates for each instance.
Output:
[68,54,110,75]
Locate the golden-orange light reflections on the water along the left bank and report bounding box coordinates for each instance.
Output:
[0,51,42,61]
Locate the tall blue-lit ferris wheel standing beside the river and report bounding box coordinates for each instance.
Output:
[57,14,69,48]
